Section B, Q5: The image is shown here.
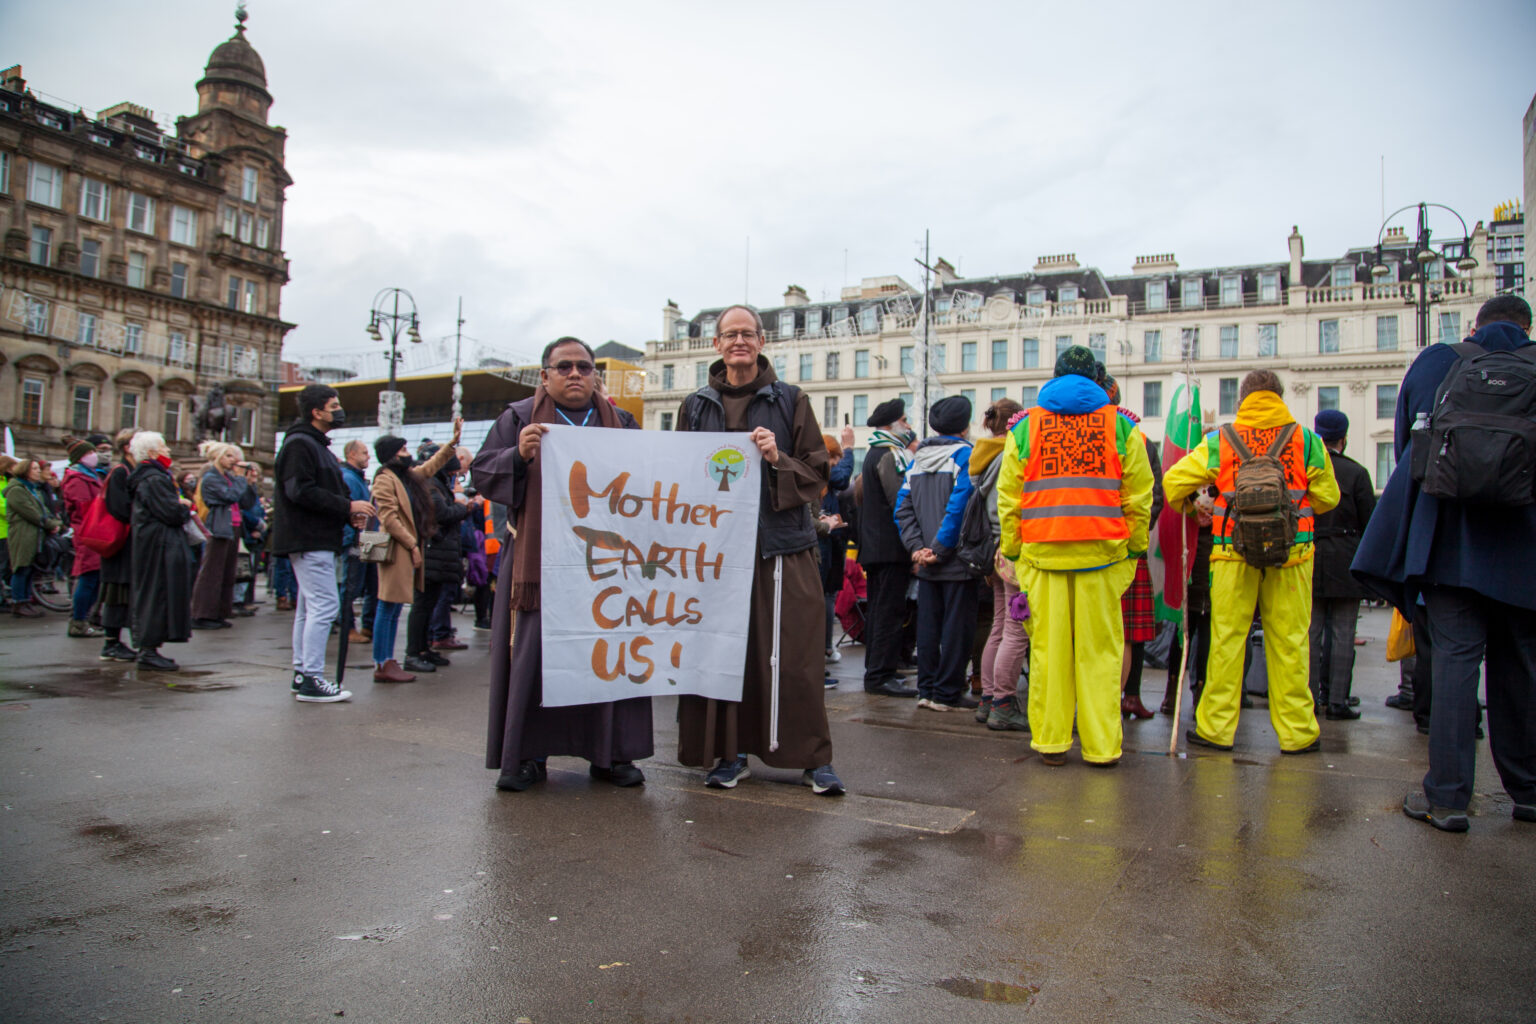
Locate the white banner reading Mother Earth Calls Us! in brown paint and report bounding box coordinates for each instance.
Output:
[539,427,762,706]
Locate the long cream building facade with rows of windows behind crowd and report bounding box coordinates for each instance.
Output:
[645,223,1495,485]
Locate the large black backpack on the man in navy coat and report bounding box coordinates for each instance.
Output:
[1412,341,1536,505]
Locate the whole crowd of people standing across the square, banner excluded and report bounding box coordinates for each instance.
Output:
[0,296,1536,831]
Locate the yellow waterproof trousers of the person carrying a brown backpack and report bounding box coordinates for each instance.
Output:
[1195,559,1318,751]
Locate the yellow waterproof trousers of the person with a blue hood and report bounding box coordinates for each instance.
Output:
[1017,559,1142,765]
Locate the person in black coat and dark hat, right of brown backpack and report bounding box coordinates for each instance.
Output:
[1309,408,1376,722]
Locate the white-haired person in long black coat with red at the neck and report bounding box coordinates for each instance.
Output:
[127,430,192,672]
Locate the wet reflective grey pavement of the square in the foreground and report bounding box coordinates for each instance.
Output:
[0,603,1536,1024]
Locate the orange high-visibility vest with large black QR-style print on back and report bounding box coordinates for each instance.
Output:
[1018,405,1130,543]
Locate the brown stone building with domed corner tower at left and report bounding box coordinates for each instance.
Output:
[0,9,293,467]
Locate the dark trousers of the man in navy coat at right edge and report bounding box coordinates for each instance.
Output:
[1413,586,1536,811]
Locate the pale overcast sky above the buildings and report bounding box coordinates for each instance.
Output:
[0,0,1536,368]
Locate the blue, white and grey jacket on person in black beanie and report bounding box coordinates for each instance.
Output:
[894,434,975,580]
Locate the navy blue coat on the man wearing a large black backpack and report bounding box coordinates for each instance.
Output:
[1350,322,1536,616]
